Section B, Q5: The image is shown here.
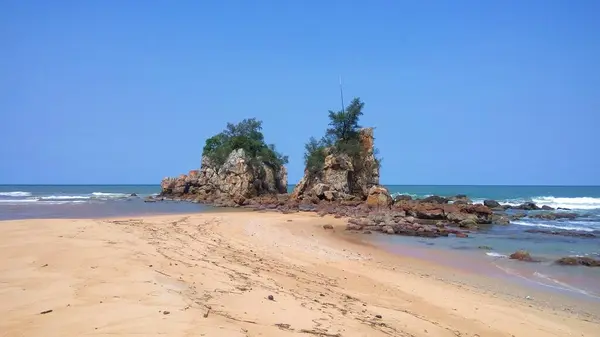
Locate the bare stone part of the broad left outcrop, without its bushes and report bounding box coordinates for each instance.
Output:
[160,149,287,205]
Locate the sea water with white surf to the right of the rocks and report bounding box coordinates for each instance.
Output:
[374,186,600,301]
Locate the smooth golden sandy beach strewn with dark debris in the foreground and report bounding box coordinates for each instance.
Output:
[0,212,600,337]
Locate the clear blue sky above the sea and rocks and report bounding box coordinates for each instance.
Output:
[0,0,600,185]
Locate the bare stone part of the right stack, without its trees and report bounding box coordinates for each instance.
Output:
[291,128,379,201]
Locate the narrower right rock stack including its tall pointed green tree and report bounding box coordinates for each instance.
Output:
[291,98,380,201]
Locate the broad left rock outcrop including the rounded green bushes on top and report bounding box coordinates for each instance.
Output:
[161,118,287,206]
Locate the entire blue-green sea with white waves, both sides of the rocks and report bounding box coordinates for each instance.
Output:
[0,185,600,300]
